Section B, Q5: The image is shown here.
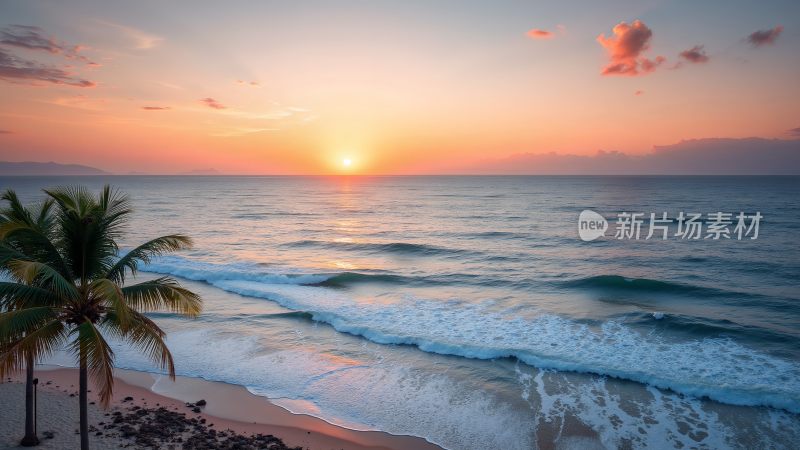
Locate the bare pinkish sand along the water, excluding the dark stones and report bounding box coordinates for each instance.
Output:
[0,365,441,450]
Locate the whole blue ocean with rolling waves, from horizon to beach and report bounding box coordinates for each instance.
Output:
[0,176,800,449]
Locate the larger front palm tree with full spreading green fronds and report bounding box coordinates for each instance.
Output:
[0,186,202,450]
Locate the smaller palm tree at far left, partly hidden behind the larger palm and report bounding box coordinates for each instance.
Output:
[0,190,54,447]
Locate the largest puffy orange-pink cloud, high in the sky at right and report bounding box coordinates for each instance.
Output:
[597,20,666,76]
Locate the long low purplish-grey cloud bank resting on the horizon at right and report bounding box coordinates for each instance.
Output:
[462,138,800,175]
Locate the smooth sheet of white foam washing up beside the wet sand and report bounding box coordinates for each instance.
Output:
[90,330,533,449]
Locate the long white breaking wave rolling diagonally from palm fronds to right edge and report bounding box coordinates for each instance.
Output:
[141,260,800,413]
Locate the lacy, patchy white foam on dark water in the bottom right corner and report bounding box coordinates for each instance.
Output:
[517,367,800,450]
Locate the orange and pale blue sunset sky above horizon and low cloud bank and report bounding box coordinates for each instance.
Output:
[0,0,800,174]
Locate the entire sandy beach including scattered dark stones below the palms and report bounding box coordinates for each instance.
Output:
[0,366,439,450]
